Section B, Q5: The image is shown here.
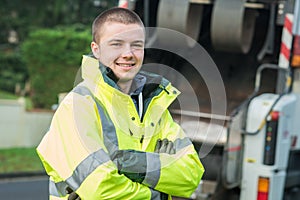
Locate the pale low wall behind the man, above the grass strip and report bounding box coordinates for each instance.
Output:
[0,98,53,148]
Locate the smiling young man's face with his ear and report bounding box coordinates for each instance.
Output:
[91,22,145,82]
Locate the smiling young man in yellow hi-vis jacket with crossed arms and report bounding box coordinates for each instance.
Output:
[37,8,204,200]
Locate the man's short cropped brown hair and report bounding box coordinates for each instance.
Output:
[92,7,144,44]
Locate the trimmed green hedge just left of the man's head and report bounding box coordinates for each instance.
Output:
[21,26,91,108]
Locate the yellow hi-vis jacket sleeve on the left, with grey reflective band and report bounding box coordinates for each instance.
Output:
[37,92,160,200]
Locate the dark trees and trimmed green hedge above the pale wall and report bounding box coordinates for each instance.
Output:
[0,0,118,107]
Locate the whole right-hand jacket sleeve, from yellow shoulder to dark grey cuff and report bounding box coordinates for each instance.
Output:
[111,111,204,198]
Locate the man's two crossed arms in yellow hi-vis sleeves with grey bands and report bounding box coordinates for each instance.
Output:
[38,94,204,199]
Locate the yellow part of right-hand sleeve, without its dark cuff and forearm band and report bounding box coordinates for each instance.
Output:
[154,110,204,198]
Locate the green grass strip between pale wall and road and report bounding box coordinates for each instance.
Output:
[0,148,44,174]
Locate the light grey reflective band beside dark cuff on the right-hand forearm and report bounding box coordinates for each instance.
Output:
[143,153,161,188]
